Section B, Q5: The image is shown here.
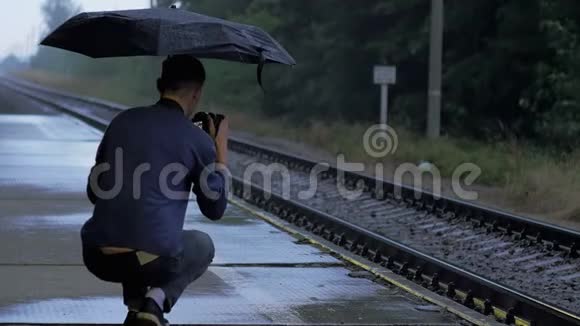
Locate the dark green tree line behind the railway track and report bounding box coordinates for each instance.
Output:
[22,0,580,150]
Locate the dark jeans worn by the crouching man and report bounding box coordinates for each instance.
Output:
[83,230,214,312]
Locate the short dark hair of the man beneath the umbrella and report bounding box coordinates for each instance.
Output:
[157,55,206,93]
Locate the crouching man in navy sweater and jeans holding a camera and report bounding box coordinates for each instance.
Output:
[81,55,229,326]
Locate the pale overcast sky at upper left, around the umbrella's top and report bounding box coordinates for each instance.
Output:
[0,0,150,60]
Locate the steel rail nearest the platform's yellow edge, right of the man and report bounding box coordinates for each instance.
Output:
[233,177,580,325]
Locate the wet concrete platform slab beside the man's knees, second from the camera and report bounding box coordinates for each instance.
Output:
[0,200,340,266]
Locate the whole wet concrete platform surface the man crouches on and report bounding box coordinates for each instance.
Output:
[0,85,458,325]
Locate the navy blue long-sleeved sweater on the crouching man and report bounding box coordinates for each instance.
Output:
[81,99,227,256]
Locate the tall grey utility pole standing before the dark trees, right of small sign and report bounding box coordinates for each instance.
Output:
[427,0,444,139]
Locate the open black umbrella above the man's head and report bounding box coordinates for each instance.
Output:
[41,8,296,85]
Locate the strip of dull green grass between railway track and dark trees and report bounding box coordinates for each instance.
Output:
[12,71,580,228]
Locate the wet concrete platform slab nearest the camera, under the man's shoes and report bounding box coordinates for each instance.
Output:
[0,267,454,325]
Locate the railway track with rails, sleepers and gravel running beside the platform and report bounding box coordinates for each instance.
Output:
[1,79,580,325]
